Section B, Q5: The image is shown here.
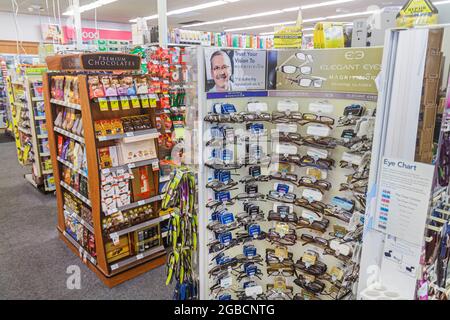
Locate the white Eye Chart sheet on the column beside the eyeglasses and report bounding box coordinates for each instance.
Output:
[375,158,434,245]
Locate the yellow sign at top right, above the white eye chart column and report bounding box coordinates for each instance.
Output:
[397,0,438,28]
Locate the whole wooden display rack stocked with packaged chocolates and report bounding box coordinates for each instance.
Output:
[44,53,170,287]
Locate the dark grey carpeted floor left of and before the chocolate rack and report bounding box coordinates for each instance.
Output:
[0,143,172,300]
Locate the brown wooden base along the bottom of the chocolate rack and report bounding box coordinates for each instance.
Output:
[58,229,166,288]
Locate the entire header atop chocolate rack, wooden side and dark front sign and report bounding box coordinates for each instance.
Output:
[45,52,141,71]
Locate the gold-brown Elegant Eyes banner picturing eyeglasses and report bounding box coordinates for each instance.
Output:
[268,47,383,95]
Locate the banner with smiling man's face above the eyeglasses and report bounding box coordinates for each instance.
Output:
[205,48,266,94]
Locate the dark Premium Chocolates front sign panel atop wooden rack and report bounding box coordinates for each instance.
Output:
[81,53,141,70]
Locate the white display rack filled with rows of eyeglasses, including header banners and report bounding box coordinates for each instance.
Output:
[193,48,382,300]
